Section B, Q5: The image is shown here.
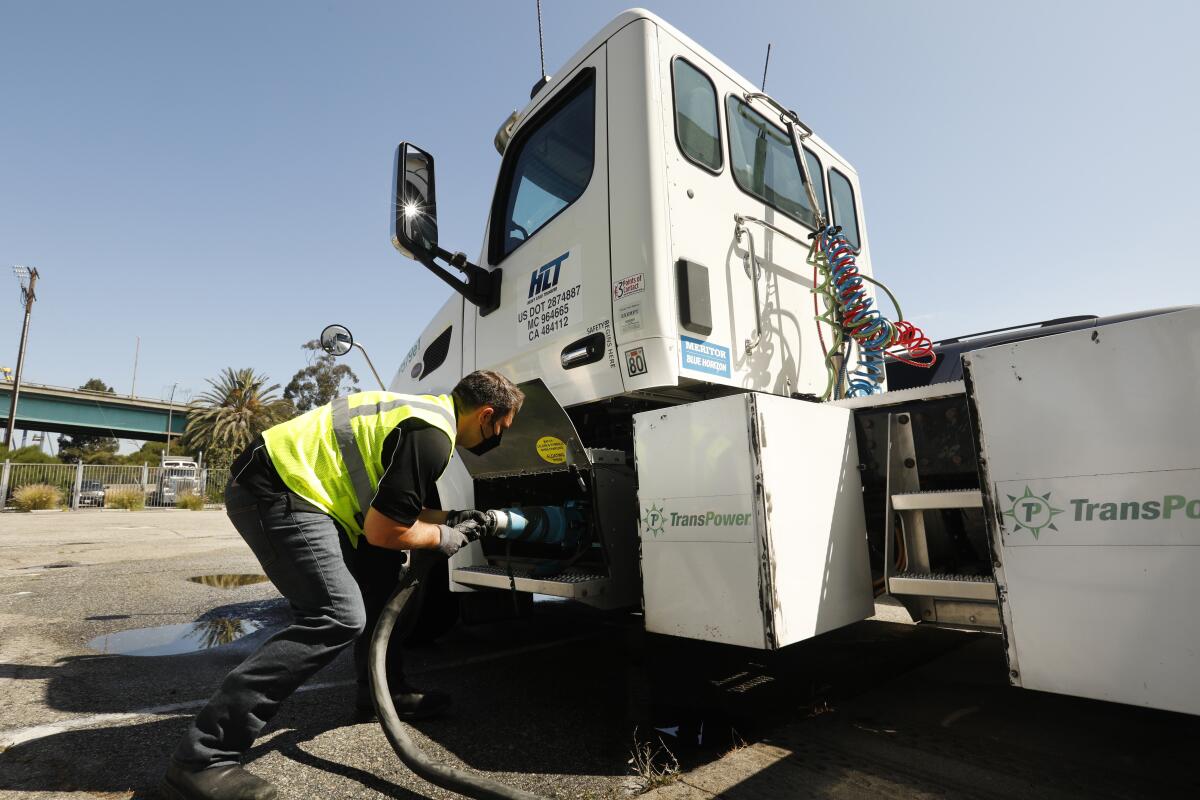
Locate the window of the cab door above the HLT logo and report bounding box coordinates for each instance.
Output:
[488,70,595,264]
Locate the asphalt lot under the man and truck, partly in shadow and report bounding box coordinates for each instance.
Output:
[0,511,1200,800]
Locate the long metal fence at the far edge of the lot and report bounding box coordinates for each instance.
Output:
[0,462,229,509]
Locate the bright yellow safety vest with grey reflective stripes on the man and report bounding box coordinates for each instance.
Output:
[263,392,457,547]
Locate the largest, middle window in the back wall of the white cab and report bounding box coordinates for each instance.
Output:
[725,95,826,228]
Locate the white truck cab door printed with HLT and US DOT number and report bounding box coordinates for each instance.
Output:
[468,46,623,405]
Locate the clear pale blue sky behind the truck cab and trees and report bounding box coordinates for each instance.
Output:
[0,0,1200,422]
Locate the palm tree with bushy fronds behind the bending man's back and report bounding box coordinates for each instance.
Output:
[184,367,295,463]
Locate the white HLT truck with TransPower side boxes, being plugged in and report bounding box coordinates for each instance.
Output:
[379,10,1200,714]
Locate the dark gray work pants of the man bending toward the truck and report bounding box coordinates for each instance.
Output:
[174,483,403,769]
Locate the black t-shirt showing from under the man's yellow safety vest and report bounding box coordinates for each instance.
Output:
[230,419,450,525]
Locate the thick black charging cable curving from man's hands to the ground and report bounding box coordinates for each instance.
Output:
[368,551,544,800]
